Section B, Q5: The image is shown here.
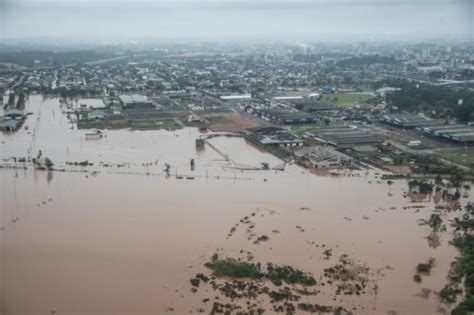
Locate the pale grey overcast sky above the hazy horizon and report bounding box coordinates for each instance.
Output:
[0,0,474,40]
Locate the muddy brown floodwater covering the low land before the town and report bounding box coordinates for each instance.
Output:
[0,96,473,315]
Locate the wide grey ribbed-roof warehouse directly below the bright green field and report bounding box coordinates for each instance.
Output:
[305,127,384,148]
